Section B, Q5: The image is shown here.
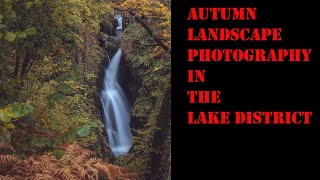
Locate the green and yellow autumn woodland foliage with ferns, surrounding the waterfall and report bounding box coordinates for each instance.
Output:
[0,0,171,180]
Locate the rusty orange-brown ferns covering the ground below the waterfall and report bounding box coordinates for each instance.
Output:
[0,144,138,180]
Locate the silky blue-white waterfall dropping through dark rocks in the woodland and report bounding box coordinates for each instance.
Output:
[101,15,132,156]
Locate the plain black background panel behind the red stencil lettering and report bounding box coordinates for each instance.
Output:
[172,0,320,179]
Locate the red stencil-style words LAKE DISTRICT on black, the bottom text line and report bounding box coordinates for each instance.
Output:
[188,111,312,125]
